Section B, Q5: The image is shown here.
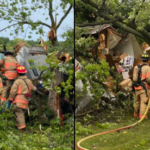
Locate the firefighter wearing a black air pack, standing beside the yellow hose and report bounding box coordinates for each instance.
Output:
[133,53,150,119]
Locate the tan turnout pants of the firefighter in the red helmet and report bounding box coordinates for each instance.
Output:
[12,104,26,130]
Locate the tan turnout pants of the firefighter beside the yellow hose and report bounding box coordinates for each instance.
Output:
[134,89,148,118]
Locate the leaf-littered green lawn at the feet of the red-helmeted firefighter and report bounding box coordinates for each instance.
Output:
[0,110,74,150]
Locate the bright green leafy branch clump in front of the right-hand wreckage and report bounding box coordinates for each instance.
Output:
[75,60,110,103]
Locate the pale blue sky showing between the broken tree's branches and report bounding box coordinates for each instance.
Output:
[0,0,74,41]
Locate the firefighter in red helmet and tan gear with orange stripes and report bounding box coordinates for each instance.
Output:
[8,65,36,130]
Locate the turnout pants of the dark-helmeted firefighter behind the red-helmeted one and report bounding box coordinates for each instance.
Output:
[1,80,14,107]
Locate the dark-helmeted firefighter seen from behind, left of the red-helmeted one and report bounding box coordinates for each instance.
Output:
[0,50,19,104]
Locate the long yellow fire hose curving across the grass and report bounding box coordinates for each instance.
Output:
[76,98,150,150]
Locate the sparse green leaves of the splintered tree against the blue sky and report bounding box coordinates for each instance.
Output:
[0,0,73,38]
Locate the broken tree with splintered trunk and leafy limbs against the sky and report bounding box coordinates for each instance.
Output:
[0,0,74,45]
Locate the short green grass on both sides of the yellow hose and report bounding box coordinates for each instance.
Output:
[75,114,150,150]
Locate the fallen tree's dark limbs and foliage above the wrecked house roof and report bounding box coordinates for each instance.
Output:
[75,0,150,44]
